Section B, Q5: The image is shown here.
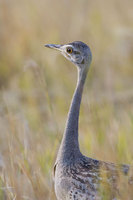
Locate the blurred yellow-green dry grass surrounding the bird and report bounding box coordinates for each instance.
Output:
[0,0,133,200]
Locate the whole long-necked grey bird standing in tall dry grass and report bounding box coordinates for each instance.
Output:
[46,42,132,200]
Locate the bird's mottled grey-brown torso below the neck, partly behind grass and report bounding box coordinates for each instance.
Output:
[55,156,133,200]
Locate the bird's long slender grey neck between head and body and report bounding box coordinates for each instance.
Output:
[57,69,88,162]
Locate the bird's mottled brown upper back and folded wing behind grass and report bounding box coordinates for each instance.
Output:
[65,156,133,184]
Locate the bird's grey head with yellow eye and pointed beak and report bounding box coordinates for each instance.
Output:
[45,41,92,70]
